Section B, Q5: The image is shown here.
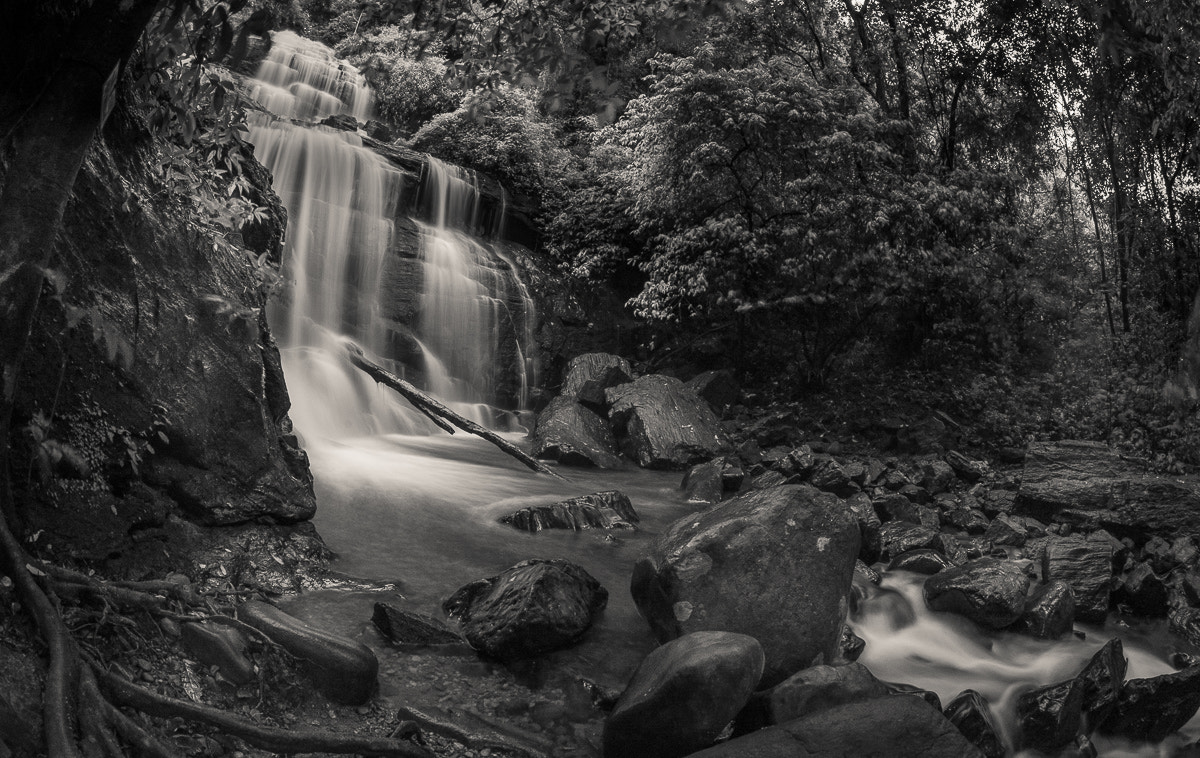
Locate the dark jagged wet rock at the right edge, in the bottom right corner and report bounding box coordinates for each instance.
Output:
[1100,666,1200,742]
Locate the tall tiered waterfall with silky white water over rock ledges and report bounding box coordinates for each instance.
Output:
[248,32,536,440]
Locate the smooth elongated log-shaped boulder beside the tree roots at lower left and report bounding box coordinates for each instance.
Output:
[238,600,379,705]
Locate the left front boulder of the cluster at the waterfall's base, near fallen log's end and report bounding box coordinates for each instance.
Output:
[533,395,620,469]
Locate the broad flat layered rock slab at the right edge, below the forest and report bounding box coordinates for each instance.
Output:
[1015,440,1200,540]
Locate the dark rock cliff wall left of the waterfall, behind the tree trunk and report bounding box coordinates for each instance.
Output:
[10,115,320,582]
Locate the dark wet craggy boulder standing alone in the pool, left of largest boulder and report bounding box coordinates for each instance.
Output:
[442,559,608,660]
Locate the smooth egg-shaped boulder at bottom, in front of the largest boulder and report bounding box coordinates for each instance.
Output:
[604,632,763,758]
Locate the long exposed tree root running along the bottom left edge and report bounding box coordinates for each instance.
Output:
[96,668,431,758]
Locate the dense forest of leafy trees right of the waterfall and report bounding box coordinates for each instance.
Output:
[302,1,1200,467]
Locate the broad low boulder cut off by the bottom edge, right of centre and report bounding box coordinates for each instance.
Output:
[692,694,983,758]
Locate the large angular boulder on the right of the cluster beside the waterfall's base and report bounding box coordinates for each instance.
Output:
[605,374,731,469]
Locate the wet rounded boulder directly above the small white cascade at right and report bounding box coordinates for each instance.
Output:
[924,558,1030,628]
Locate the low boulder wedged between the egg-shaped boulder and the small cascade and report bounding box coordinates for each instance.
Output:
[734,663,888,734]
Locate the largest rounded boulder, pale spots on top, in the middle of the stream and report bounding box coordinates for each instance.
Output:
[631,485,859,686]
